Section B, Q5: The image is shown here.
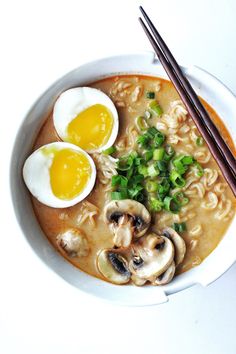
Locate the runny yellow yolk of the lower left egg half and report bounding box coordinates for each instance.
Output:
[43,149,92,200]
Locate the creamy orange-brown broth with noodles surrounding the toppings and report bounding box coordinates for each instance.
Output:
[32,75,235,285]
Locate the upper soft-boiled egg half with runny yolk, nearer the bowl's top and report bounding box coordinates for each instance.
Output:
[53,87,119,153]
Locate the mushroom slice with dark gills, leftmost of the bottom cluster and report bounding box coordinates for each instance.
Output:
[97,249,131,284]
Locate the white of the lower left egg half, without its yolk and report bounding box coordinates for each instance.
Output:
[23,142,96,208]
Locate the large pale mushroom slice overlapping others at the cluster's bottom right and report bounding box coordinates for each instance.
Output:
[129,233,174,280]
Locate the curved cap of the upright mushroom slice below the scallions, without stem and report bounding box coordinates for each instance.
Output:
[104,199,151,237]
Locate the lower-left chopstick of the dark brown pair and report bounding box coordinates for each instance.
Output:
[139,10,236,196]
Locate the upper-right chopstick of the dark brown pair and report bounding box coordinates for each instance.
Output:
[140,6,236,176]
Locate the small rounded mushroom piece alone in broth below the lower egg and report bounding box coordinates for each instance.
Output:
[57,228,89,257]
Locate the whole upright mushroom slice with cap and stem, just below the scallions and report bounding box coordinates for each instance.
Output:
[104,199,151,247]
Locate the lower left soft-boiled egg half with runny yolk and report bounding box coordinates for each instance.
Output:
[23,142,96,208]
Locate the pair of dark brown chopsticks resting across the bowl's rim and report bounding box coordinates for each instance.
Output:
[139,6,236,197]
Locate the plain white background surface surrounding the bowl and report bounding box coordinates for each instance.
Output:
[0,0,236,354]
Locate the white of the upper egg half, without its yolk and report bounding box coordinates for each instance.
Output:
[53,87,119,153]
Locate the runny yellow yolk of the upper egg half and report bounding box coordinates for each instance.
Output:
[66,104,114,151]
